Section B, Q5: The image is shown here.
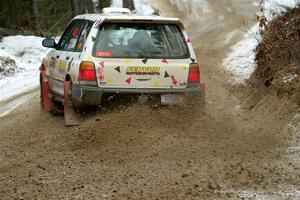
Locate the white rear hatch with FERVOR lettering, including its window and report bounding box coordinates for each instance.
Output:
[93,22,191,89]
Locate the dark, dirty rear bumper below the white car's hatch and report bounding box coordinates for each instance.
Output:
[72,84,205,107]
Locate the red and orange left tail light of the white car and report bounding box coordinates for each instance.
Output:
[79,61,96,81]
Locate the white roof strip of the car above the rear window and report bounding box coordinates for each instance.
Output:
[74,13,181,23]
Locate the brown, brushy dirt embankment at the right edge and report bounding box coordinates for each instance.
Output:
[249,7,300,103]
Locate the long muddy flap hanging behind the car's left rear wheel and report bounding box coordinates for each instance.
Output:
[64,81,80,126]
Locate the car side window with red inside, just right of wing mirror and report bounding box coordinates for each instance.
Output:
[58,20,83,51]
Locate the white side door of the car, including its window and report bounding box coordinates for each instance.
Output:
[49,19,84,96]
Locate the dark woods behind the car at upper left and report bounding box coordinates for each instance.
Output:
[0,0,134,36]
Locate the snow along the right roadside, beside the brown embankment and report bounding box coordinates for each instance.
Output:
[223,0,300,84]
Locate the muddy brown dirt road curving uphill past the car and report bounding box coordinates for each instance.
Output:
[0,0,300,200]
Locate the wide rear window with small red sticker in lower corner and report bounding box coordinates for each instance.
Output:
[93,23,189,59]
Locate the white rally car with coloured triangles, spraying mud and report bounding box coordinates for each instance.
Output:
[40,9,205,125]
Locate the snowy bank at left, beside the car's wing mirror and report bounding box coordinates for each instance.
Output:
[0,35,49,102]
